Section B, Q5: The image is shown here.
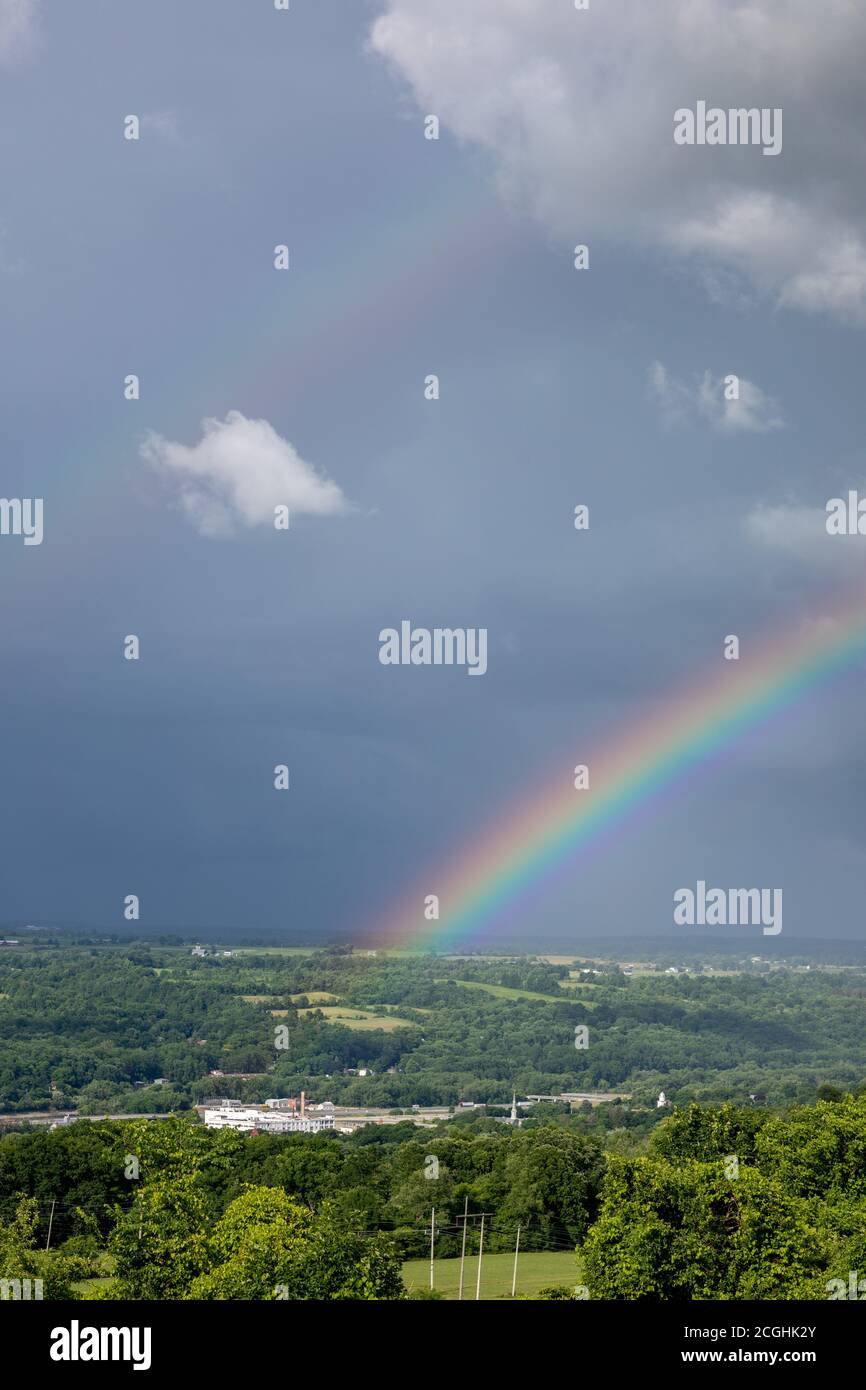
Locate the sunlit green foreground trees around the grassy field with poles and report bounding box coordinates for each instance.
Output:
[0,1095,866,1300]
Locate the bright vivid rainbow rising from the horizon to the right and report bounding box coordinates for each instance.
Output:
[370,594,866,949]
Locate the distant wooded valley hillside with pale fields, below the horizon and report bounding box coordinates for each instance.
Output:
[0,941,866,1112]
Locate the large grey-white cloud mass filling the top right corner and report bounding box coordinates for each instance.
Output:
[370,0,866,322]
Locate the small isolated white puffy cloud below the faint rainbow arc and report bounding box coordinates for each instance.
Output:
[140,410,348,537]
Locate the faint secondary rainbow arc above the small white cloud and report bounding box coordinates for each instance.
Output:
[54,175,500,517]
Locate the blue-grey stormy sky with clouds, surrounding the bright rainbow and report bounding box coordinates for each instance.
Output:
[0,0,866,940]
